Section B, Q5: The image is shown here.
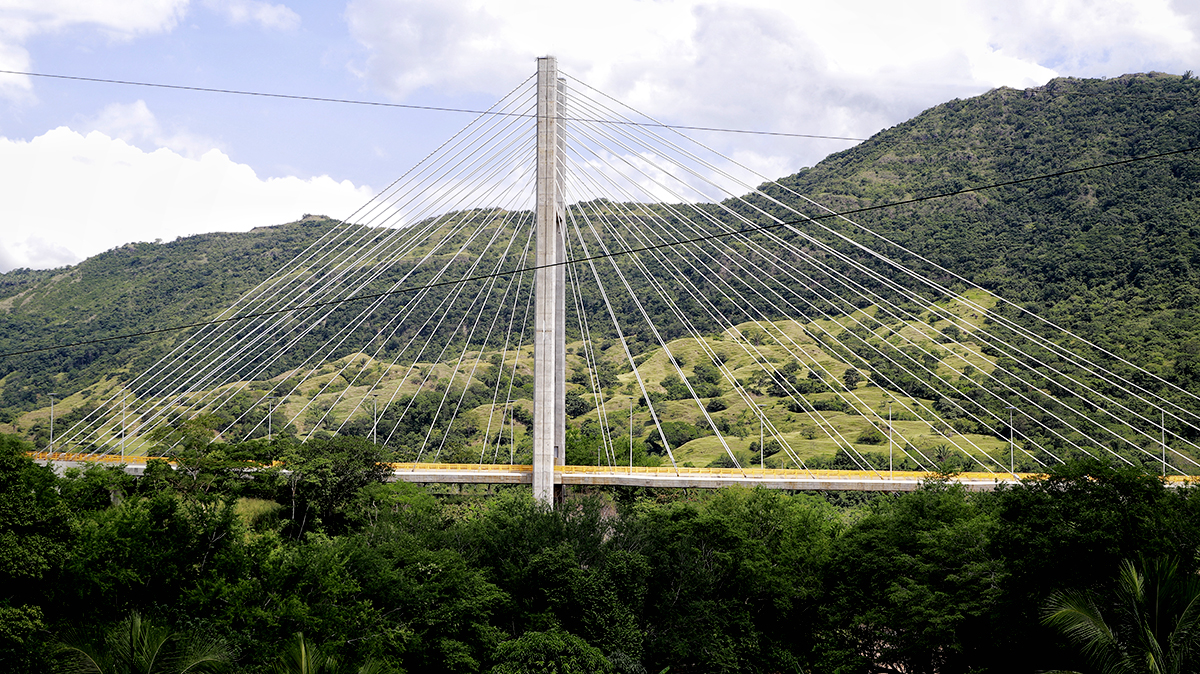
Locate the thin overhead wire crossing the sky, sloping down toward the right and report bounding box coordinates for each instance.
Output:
[0,70,866,142]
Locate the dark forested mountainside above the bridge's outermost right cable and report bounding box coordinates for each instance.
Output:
[766,73,1200,390]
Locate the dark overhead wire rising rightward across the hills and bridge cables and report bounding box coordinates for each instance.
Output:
[0,140,1200,359]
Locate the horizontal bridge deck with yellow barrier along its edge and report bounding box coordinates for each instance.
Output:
[31,452,1196,492]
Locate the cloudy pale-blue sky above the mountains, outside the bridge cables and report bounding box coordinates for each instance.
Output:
[0,0,1200,272]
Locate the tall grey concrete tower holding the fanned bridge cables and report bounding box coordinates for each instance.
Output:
[533,56,566,506]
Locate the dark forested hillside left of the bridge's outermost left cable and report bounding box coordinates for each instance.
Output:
[0,217,329,412]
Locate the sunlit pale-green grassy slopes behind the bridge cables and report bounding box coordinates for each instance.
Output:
[11,303,1007,468]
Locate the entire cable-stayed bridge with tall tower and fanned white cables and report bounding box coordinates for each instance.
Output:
[37,59,1200,501]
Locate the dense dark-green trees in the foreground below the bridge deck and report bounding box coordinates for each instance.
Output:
[0,435,1200,673]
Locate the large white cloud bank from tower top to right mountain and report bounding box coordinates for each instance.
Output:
[346,0,1200,176]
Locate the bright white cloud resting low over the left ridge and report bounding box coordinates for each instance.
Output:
[0,127,372,271]
